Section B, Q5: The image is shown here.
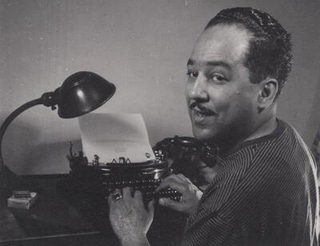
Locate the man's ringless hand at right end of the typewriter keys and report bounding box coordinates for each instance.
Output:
[156,174,202,214]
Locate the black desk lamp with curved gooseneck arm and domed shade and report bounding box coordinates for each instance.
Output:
[0,71,116,202]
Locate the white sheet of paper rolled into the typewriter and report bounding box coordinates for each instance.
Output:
[78,113,155,163]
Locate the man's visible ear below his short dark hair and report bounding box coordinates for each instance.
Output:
[258,78,279,110]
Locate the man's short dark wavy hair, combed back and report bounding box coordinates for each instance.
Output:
[205,7,292,94]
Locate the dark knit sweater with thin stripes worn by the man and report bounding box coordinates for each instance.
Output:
[182,120,319,246]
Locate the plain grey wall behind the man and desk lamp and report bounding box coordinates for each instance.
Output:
[0,0,320,174]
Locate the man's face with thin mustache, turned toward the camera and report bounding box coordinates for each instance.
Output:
[186,25,259,143]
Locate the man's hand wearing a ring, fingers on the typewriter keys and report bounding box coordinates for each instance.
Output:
[108,187,154,246]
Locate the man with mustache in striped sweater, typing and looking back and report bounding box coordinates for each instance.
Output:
[109,8,319,246]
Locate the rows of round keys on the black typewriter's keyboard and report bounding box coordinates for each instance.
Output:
[103,179,181,201]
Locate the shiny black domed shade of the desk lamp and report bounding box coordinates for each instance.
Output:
[55,71,116,118]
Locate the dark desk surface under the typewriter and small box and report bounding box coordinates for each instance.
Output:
[0,175,184,246]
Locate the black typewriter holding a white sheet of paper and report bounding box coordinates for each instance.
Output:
[64,145,181,202]
